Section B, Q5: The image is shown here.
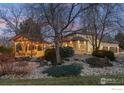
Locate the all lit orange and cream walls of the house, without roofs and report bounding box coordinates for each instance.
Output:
[12,36,119,57]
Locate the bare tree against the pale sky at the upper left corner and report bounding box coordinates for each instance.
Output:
[0,6,24,34]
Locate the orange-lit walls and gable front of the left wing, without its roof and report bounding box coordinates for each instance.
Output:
[12,38,50,57]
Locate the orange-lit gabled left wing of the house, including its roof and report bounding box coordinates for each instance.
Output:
[10,35,50,57]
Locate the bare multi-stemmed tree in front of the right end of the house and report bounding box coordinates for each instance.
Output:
[81,4,119,51]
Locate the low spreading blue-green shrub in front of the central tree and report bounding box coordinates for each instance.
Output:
[43,64,82,77]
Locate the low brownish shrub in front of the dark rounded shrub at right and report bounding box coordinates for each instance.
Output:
[86,57,113,67]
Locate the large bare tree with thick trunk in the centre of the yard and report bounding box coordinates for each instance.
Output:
[27,3,92,63]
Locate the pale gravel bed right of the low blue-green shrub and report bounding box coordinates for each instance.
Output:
[64,55,124,76]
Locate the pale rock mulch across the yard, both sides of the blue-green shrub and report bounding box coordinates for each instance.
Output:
[0,56,124,79]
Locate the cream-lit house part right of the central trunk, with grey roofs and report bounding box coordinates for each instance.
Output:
[62,32,119,54]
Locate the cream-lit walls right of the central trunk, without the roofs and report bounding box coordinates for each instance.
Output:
[63,41,119,54]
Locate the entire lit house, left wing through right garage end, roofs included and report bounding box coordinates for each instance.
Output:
[10,33,119,57]
